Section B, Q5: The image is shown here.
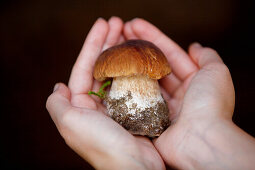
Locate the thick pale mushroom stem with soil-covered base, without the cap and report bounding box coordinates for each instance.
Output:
[106,76,169,137]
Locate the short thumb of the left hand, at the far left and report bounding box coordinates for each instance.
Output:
[46,83,72,124]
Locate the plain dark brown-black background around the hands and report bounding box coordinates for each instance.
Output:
[0,0,255,169]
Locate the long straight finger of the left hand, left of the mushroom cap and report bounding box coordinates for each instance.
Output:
[69,18,109,95]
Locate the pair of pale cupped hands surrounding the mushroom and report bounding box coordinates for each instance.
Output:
[46,17,255,169]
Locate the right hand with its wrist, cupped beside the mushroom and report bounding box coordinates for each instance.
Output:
[124,19,255,169]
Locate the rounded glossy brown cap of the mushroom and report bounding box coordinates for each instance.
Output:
[94,40,171,81]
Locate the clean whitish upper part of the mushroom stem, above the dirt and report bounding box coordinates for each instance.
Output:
[108,76,164,115]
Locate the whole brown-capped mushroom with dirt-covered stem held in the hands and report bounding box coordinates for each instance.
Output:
[94,40,171,137]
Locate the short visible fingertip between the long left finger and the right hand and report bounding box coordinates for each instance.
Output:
[103,16,123,50]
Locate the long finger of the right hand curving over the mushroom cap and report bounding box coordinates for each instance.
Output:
[124,19,197,80]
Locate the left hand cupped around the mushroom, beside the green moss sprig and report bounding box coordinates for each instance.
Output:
[47,17,165,169]
